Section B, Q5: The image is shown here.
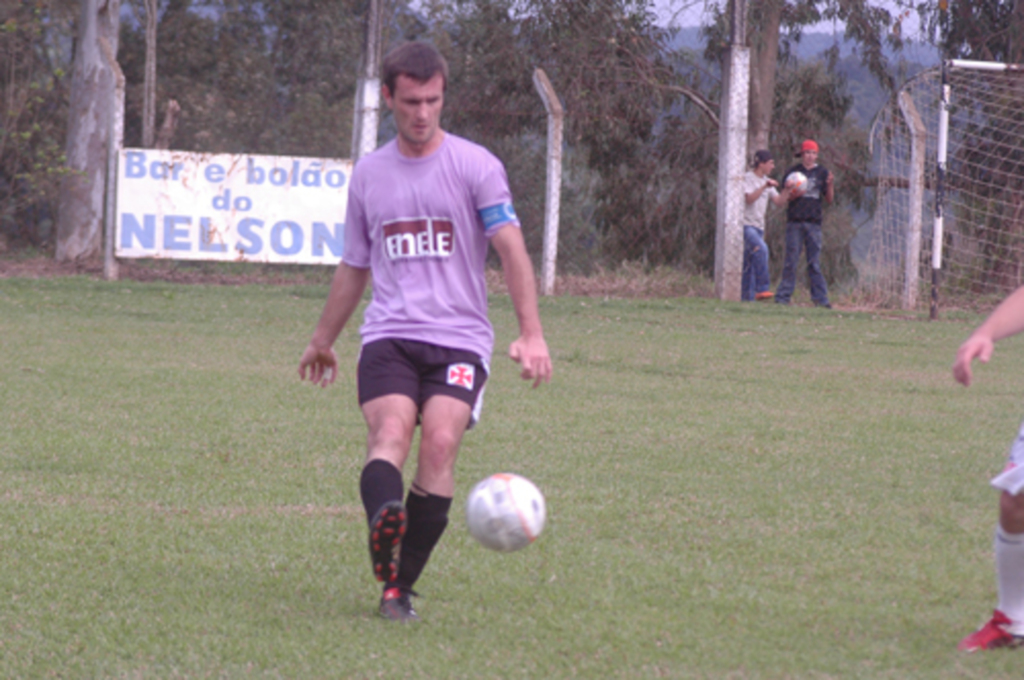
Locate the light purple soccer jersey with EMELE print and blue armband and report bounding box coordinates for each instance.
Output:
[342,133,519,362]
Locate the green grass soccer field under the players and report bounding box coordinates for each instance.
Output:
[0,279,1024,679]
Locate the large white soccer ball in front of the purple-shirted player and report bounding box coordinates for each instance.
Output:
[466,472,547,552]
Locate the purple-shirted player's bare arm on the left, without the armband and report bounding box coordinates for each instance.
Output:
[299,262,370,387]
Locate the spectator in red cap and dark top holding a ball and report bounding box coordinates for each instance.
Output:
[775,139,835,309]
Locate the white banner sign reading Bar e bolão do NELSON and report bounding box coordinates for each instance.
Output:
[115,148,352,264]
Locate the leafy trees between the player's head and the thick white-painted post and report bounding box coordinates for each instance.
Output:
[415,0,717,271]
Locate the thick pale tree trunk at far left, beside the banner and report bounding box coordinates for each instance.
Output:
[56,0,121,261]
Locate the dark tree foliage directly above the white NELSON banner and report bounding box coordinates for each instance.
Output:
[119,0,365,158]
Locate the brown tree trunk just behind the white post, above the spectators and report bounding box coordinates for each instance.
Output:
[746,0,784,154]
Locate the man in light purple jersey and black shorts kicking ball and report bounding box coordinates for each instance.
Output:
[299,42,552,622]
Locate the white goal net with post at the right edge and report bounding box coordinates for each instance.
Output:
[859,60,1024,311]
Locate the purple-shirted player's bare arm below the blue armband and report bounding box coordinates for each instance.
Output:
[490,225,552,387]
